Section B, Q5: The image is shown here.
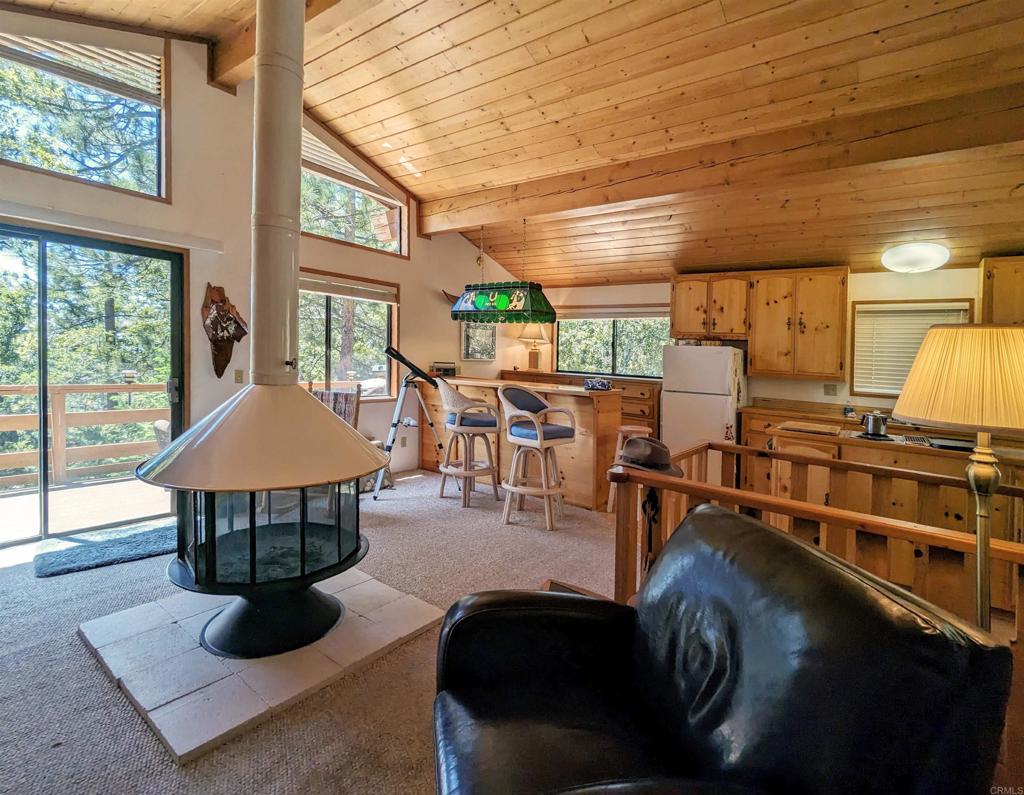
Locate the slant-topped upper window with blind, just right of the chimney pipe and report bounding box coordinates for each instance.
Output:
[300,130,404,254]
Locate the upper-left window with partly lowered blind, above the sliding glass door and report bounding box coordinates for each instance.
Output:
[0,35,163,196]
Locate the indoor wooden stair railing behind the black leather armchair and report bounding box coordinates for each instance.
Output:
[608,444,1024,631]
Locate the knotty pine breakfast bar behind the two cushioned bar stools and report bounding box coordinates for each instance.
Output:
[420,377,623,510]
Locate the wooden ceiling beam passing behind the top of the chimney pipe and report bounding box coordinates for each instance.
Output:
[210,0,395,88]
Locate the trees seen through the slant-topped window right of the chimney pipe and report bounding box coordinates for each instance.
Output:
[299,169,398,252]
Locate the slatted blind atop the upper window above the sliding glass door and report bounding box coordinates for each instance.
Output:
[0,33,163,108]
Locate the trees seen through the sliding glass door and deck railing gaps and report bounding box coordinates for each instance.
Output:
[0,236,171,483]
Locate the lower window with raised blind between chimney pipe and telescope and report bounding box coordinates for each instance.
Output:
[299,273,396,398]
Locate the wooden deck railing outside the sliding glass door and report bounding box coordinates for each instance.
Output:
[0,383,171,487]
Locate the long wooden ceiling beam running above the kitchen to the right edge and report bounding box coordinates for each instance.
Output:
[420,85,1024,234]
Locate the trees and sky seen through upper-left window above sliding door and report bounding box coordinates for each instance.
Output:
[0,58,160,195]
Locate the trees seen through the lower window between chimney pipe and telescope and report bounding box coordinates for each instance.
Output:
[299,291,391,395]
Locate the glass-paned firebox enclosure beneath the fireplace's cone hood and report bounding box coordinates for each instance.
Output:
[173,480,359,592]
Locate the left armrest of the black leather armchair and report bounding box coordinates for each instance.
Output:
[437,591,636,693]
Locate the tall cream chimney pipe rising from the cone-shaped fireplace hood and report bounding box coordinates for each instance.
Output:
[250,0,305,384]
